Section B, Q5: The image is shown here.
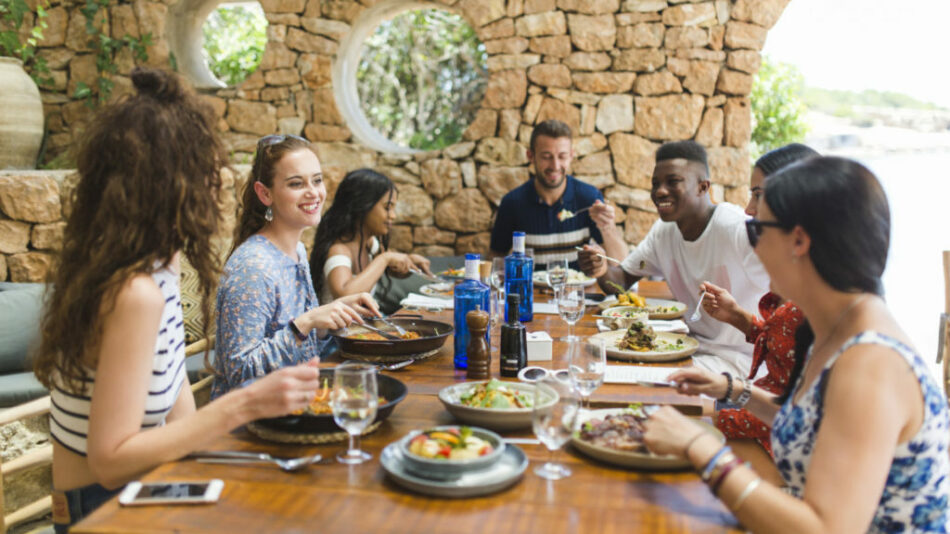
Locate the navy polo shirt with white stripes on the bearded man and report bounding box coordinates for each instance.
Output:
[491,175,604,269]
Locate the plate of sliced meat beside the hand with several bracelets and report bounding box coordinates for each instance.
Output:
[571,403,726,470]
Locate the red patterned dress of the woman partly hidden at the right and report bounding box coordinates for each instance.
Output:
[716,292,805,455]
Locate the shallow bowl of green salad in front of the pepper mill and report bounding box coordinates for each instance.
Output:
[439,378,557,431]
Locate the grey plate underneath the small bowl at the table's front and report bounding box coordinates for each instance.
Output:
[379,441,528,499]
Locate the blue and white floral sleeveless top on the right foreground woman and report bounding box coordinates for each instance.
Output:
[772,331,950,533]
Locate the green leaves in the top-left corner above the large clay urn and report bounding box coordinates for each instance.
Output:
[0,0,53,85]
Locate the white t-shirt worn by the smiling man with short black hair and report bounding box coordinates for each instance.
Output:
[621,203,769,376]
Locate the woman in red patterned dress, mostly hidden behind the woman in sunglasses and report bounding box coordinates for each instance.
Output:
[701,143,819,454]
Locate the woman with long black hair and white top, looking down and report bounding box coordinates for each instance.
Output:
[310,169,432,308]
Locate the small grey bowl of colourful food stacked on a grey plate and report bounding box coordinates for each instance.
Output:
[399,425,505,479]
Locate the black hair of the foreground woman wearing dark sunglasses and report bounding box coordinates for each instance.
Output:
[765,157,891,404]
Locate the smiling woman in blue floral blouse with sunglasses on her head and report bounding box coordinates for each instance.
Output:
[211,135,379,398]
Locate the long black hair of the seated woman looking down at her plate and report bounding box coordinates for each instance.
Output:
[310,169,396,304]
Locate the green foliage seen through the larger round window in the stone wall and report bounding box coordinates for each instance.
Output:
[356,9,488,150]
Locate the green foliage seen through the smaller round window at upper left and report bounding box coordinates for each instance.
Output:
[202,5,267,85]
